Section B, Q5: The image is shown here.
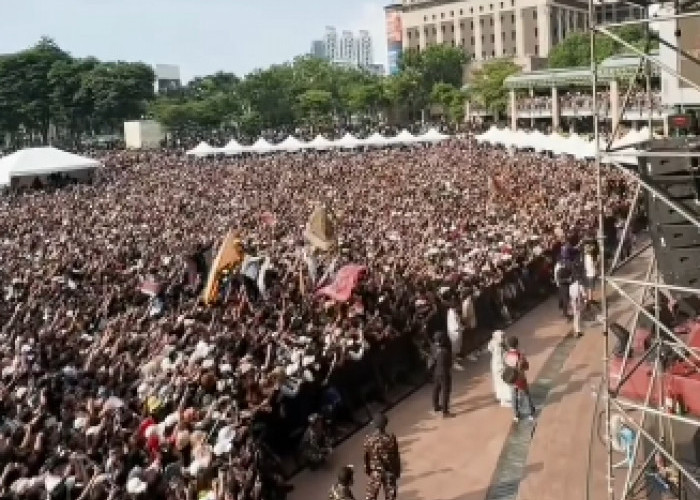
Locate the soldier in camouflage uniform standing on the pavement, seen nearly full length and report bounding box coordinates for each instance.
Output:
[365,414,401,500]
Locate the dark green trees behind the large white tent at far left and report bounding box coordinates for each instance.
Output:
[0,38,155,147]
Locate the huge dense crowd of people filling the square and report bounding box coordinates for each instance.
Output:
[0,139,627,500]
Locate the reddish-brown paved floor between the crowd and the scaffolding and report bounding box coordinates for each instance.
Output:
[289,254,647,500]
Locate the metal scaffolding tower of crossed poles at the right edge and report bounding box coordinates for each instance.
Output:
[588,0,700,500]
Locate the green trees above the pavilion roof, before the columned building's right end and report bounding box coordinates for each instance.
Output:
[549,25,659,68]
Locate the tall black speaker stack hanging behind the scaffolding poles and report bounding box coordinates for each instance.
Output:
[639,138,700,292]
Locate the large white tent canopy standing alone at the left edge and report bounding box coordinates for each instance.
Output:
[0,147,101,186]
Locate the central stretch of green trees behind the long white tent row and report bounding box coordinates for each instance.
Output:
[150,46,467,143]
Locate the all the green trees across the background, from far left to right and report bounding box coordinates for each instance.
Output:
[0,26,644,146]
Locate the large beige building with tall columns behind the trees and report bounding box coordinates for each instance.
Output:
[385,0,636,71]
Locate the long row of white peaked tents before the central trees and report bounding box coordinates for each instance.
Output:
[187,128,450,157]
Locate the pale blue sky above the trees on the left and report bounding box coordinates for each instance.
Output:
[0,0,391,81]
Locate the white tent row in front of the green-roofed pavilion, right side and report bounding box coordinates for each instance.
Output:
[476,127,650,164]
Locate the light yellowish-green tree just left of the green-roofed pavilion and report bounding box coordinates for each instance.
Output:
[469,59,520,116]
